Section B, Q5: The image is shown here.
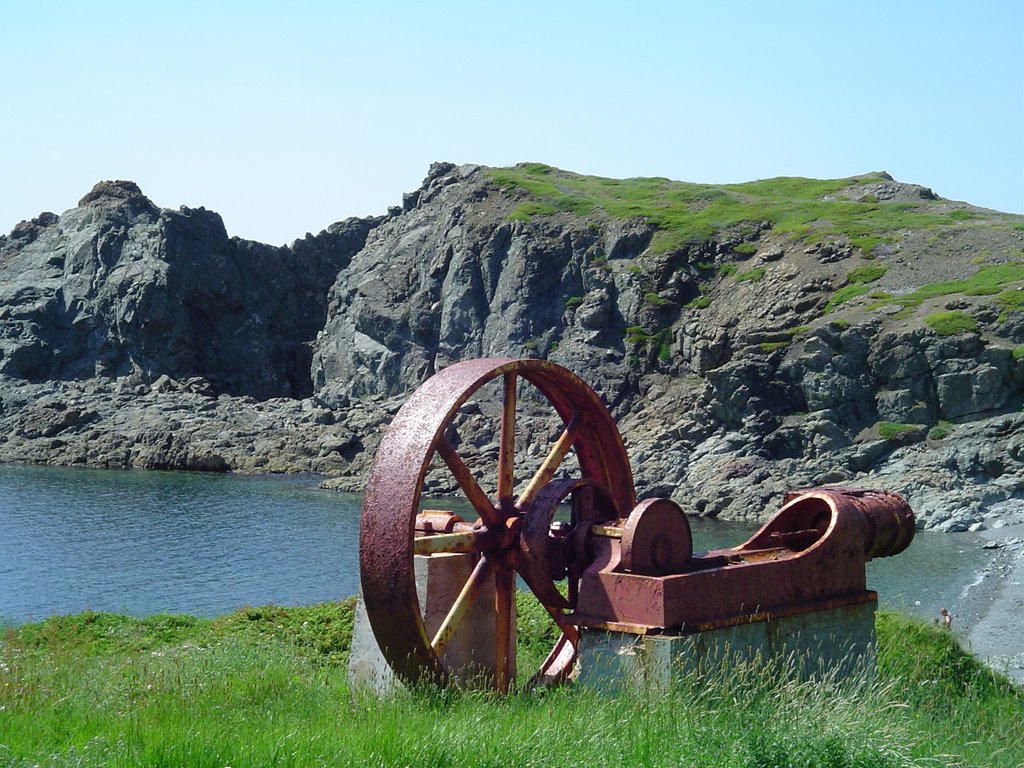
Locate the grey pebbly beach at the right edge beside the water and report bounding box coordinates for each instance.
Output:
[953,510,1024,683]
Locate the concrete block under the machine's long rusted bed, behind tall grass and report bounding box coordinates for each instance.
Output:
[577,600,878,690]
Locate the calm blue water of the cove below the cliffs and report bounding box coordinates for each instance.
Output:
[0,466,988,624]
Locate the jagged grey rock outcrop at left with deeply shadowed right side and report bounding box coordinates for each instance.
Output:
[0,181,372,397]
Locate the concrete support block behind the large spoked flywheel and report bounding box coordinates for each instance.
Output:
[348,554,515,695]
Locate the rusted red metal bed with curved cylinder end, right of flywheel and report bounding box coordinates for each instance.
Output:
[573,487,914,630]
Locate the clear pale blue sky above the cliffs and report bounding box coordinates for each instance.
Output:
[0,0,1024,244]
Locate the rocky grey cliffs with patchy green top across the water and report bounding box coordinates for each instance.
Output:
[0,164,1024,529]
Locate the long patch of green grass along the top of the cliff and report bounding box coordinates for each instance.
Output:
[490,163,1007,254]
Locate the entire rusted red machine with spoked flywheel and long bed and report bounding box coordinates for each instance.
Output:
[359,358,914,691]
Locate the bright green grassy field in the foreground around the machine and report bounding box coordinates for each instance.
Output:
[0,603,1024,768]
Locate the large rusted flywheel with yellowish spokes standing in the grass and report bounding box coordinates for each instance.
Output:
[359,358,636,692]
